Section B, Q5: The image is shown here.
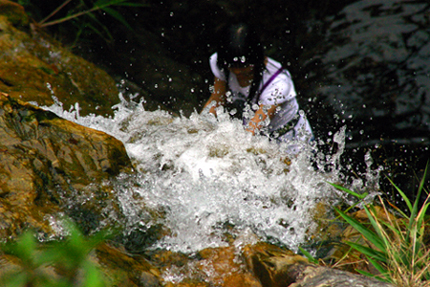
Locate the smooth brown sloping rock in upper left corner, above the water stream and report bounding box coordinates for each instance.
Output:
[0,0,119,115]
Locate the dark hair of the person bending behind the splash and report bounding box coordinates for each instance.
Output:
[217,22,265,105]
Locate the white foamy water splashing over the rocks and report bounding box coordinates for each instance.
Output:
[44,95,344,252]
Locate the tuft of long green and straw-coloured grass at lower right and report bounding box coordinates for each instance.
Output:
[332,163,430,286]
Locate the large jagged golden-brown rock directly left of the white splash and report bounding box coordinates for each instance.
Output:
[0,94,131,239]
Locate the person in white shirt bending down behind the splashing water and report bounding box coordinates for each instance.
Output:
[203,23,313,146]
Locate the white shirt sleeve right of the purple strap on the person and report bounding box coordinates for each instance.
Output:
[260,71,296,105]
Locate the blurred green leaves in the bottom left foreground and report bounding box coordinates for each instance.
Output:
[0,223,112,287]
